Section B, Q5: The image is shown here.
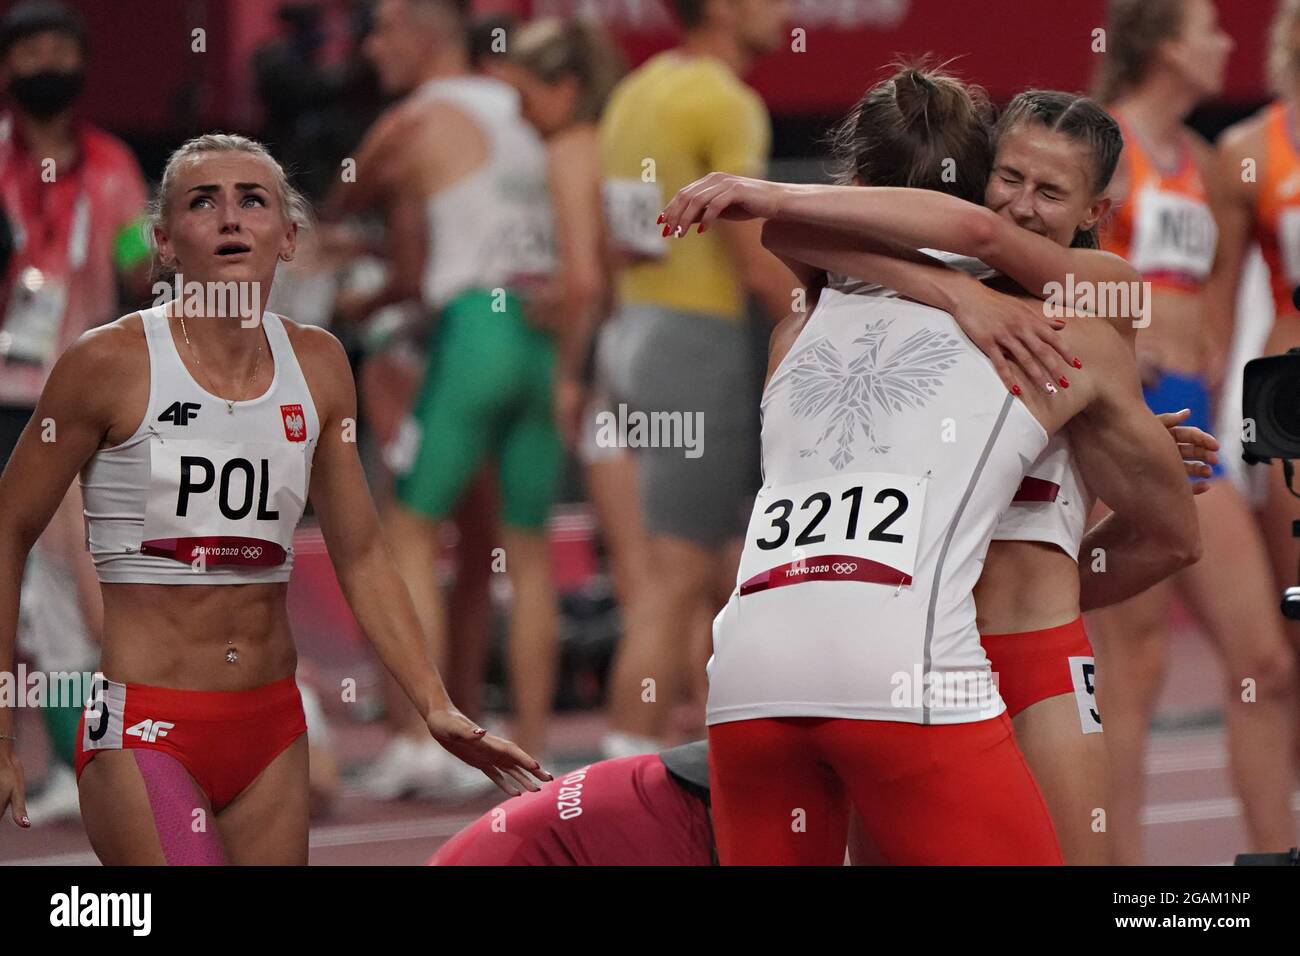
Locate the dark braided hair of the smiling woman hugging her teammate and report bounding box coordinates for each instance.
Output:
[996,90,1125,248]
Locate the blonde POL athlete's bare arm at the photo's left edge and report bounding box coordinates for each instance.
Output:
[0,323,139,822]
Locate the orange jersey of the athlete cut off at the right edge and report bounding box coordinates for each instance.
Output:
[1255,103,1300,315]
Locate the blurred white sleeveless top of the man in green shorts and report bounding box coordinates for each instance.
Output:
[415,77,556,307]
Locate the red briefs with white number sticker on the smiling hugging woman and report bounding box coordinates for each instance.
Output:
[980,615,1101,732]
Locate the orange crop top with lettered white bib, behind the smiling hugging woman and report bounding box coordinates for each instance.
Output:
[1101,120,1218,291]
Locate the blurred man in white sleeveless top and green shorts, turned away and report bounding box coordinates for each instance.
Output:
[330,0,560,796]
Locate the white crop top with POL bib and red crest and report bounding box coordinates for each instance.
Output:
[82,306,320,584]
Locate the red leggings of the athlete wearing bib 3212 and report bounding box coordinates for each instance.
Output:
[709,713,1061,866]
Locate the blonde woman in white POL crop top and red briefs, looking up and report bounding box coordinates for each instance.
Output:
[0,134,549,865]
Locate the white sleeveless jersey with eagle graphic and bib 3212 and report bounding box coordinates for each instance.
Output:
[707,289,1048,724]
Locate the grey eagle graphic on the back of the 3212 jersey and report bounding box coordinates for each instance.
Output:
[774,319,966,471]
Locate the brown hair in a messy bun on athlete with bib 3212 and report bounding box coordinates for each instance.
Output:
[831,64,993,203]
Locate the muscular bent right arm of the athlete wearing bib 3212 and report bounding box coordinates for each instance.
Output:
[1024,320,1200,610]
